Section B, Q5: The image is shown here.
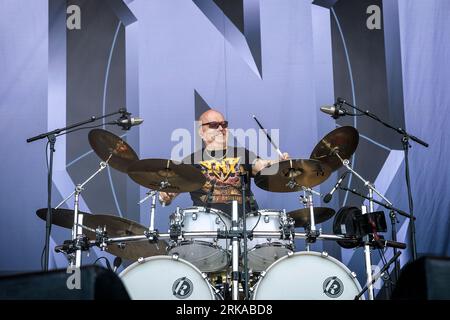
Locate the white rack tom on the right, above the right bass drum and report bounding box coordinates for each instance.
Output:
[241,209,294,272]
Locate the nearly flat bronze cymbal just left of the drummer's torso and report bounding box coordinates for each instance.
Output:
[128,159,206,193]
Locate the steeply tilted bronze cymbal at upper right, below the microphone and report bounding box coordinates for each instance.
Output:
[310,126,359,171]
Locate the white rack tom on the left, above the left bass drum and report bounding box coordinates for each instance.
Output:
[169,207,231,272]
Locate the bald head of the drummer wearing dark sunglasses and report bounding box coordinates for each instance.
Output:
[198,109,228,149]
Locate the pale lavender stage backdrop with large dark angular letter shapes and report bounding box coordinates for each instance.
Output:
[0,0,450,300]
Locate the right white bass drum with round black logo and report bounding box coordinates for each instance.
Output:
[253,251,361,300]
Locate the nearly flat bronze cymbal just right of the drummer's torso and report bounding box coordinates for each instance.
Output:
[255,159,331,192]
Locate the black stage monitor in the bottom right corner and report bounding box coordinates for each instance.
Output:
[392,257,450,300]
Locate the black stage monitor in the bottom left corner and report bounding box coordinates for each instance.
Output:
[0,266,130,300]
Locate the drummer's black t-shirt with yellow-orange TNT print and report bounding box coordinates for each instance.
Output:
[183,147,258,216]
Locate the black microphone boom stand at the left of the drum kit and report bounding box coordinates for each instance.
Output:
[27,108,126,271]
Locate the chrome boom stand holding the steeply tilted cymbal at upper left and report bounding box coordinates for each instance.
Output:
[55,153,113,268]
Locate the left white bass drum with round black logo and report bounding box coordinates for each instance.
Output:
[119,256,216,300]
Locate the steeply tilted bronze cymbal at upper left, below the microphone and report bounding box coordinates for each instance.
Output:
[88,129,139,173]
